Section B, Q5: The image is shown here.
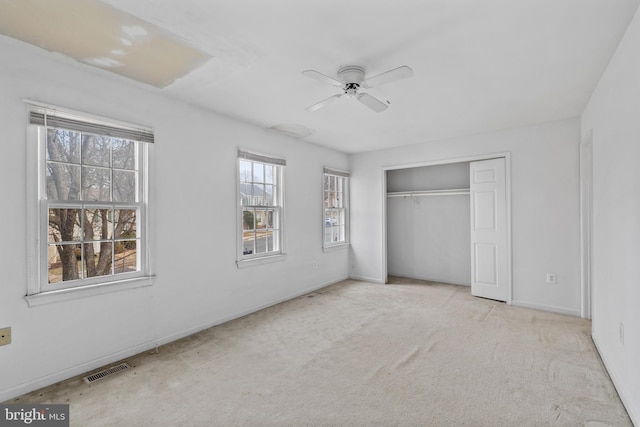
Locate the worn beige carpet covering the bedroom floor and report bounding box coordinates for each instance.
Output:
[8,279,631,427]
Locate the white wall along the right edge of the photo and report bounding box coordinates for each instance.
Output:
[582,5,640,425]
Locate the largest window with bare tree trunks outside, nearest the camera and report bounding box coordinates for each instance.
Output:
[29,105,153,295]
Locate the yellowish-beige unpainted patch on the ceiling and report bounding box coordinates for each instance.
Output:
[0,0,211,88]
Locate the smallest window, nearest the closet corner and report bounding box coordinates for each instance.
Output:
[323,168,349,247]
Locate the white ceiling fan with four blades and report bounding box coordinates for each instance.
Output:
[302,65,413,113]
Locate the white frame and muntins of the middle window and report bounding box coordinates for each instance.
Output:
[235,148,286,268]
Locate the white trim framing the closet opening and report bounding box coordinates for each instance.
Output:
[381,151,513,305]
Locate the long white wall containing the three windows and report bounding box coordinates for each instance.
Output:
[0,36,349,401]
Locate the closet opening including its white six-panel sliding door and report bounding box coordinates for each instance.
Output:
[383,153,512,303]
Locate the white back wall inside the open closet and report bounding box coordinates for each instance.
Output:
[387,162,471,286]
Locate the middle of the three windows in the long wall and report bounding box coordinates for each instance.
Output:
[238,150,286,261]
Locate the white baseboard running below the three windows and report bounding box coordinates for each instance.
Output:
[0,276,349,402]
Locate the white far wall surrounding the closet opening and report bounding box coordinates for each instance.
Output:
[351,118,580,315]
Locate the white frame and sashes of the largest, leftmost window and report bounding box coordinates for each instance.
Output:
[25,101,154,306]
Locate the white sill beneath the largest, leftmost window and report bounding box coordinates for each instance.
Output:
[24,276,156,307]
